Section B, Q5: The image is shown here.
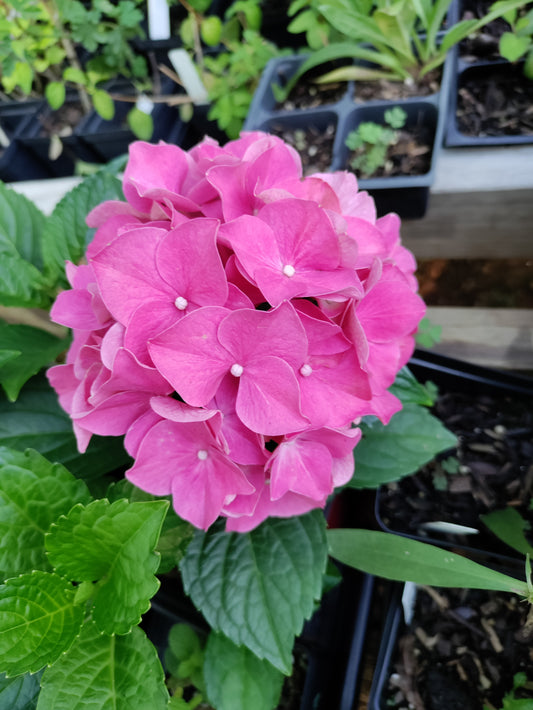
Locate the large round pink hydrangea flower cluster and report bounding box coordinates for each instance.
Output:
[48,132,425,531]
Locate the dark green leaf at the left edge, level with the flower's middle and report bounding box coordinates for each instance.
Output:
[0,321,68,402]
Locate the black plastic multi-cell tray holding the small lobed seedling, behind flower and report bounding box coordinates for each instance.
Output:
[244,55,451,219]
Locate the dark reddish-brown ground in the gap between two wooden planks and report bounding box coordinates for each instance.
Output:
[416,259,533,308]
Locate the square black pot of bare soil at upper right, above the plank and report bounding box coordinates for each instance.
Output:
[445,50,533,147]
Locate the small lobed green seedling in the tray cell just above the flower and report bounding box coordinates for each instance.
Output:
[346,106,407,177]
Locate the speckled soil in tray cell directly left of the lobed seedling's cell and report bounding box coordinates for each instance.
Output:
[269,123,335,175]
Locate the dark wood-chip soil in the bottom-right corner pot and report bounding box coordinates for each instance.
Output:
[384,588,533,710]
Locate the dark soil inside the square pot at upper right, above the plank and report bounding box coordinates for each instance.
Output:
[456,65,533,136]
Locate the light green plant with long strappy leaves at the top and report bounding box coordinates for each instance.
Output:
[283,0,523,97]
